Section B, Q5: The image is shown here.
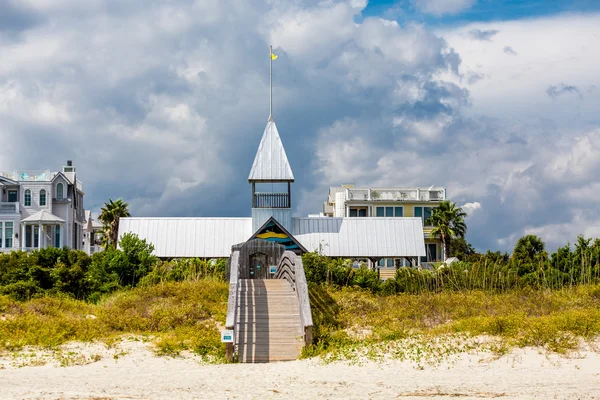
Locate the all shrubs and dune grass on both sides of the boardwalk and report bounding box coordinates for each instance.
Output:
[0,227,600,364]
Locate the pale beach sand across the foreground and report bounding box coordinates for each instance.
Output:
[0,341,600,400]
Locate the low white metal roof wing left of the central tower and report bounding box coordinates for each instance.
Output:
[119,218,253,258]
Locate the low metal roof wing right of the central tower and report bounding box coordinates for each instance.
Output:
[292,217,426,258]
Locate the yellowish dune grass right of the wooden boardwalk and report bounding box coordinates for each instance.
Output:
[304,285,600,359]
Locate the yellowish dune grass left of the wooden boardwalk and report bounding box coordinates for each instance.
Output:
[0,279,228,359]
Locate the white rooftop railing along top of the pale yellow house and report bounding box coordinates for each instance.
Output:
[346,188,446,201]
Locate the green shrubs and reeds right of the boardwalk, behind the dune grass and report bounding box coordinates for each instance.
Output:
[303,235,600,294]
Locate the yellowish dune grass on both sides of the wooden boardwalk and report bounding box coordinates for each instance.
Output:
[0,278,600,362]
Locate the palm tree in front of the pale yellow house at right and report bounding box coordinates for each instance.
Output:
[427,201,467,259]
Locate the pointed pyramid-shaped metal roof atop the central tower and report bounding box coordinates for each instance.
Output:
[248,118,294,182]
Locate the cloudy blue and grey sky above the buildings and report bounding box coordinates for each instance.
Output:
[0,0,600,251]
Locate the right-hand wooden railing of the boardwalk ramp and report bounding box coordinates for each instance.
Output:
[274,251,313,346]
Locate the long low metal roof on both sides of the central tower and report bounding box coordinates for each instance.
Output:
[119,217,425,258]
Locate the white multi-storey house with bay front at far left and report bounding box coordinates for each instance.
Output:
[0,161,85,252]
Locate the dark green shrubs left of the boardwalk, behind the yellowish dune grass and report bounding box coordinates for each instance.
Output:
[0,234,226,302]
